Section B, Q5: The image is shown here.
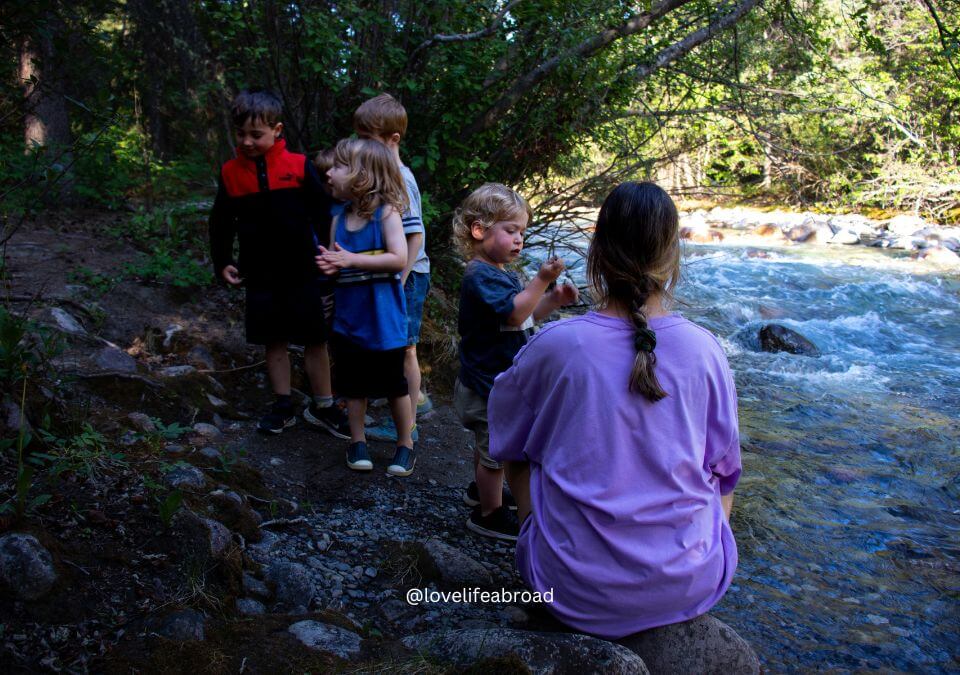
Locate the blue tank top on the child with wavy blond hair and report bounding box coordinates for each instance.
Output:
[333,204,407,352]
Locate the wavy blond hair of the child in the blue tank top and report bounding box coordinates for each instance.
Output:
[333,138,410,218]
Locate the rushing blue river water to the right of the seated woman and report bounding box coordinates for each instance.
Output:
[531,238,960,672]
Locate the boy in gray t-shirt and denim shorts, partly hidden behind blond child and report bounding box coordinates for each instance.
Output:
[353,94,430,441]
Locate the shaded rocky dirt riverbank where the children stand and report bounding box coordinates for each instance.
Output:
[0,220,664,673]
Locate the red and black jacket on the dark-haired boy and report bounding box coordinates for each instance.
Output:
[210,139,333,288]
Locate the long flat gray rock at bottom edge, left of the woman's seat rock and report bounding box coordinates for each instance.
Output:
[402,628,649,675]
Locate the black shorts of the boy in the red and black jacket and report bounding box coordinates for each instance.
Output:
[246,281,333,345]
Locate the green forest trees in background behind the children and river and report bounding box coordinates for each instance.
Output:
[0,0,960,286]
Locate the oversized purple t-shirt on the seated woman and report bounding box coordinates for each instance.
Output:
[488,312,740,639]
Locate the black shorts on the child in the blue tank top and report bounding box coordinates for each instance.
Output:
[330,333,408,398]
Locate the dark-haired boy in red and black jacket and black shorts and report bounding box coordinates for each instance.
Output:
[210,89,350,439]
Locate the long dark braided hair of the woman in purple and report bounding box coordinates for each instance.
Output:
[587,183,680,402]
